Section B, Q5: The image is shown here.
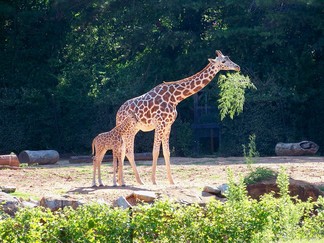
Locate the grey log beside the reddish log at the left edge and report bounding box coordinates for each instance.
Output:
[18,150,60,165]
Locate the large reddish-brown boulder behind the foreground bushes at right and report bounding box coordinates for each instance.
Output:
[247,179,324,201]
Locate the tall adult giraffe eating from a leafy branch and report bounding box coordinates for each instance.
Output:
[116,51,240,184]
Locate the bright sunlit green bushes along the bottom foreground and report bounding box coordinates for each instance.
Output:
[0,169,324,243]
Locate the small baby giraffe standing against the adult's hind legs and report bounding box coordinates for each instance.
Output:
[92,114,138,187]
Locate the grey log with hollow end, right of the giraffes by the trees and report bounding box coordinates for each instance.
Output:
[275,141,319,156]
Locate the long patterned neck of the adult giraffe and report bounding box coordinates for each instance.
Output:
[163,63,219,105]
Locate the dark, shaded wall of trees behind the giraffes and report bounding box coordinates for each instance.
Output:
[0,0,324,155]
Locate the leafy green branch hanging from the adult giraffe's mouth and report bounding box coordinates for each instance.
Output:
[217,72,256,120]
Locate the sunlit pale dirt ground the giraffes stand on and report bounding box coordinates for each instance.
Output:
[0,157,324,204]
